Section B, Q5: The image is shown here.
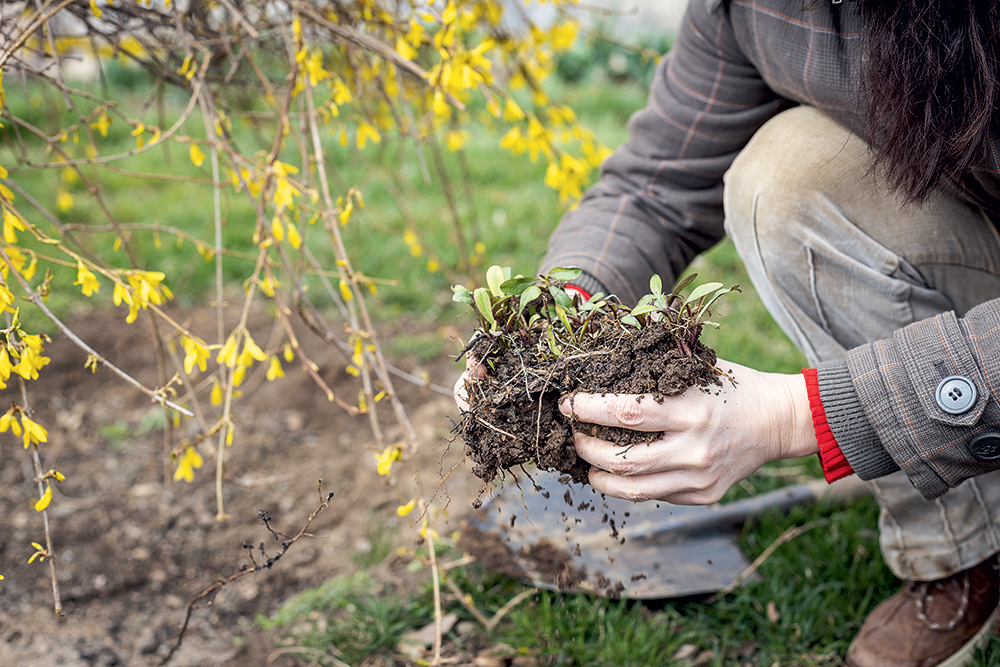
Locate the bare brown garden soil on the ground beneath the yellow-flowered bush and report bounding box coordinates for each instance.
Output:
[0,310,482,667]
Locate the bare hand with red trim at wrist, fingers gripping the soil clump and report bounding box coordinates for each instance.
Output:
[559,360,819,505]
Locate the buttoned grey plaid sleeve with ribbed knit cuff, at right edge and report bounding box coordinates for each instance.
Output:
[819,298,1000,499]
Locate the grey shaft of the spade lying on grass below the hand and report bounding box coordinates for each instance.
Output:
[649,475,870,535]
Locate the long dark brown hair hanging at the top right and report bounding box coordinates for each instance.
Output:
[859,0,1000,201]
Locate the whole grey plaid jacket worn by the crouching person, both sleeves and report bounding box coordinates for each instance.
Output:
[541,0,1000,498]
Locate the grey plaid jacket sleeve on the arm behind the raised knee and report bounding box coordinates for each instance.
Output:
[542,0,791,304]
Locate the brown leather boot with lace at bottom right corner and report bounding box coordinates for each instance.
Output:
[847,556,1000,667]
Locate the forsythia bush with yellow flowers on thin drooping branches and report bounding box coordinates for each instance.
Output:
[0,0,607,608]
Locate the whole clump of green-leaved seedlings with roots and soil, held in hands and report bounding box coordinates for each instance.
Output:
[452,266,738,498]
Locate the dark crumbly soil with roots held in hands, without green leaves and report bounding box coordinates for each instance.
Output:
[457,284,720,494]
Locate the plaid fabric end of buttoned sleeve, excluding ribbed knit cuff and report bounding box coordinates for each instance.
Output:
[847,310,1000,500]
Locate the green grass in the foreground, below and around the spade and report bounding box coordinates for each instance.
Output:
[259,499,895,667]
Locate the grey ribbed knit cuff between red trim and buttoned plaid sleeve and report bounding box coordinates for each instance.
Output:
[807,359,899,481]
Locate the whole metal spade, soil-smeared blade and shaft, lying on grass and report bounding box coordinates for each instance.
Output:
[459,471,868,599]
